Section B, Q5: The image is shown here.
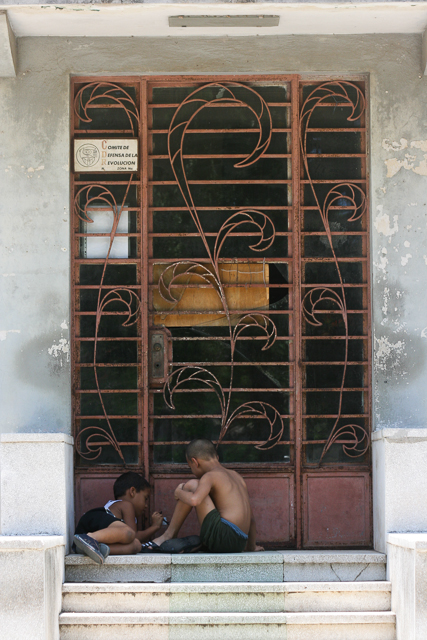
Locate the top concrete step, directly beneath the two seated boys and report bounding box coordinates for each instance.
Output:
[65,551,386,583]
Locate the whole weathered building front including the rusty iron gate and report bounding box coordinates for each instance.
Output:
[0,2,427,640]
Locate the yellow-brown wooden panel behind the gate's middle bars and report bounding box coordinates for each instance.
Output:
[153,262,269,327]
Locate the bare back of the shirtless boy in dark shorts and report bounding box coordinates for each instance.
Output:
[205,465,251,534]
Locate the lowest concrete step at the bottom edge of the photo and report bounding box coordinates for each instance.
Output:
[60,612,396,640]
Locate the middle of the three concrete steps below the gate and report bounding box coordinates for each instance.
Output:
[62,582,391,613]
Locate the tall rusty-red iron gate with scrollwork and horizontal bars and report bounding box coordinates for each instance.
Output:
[71,76,371,548]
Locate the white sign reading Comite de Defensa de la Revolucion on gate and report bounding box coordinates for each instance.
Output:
[74,138,138,173]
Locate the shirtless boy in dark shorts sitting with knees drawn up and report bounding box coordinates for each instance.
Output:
[142,440,263,553]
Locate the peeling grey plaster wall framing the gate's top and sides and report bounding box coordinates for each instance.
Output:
[0,35,427,433]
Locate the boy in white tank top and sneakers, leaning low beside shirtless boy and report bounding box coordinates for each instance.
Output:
[73,471,163,564]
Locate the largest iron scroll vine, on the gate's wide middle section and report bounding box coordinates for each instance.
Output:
[158,82,284,449]
